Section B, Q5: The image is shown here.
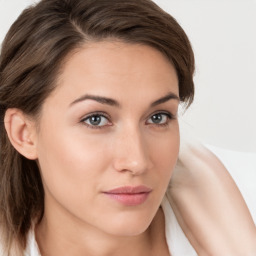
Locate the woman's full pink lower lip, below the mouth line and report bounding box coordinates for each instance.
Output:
[105,192,150,206]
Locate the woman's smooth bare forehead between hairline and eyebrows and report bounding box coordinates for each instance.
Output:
[46,42,178,106]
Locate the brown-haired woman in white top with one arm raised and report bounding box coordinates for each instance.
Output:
[0,0,255,256]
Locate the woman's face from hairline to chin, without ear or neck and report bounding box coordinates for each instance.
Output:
[36,42,179,236]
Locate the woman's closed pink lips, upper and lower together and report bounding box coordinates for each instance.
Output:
[103,186,152,206]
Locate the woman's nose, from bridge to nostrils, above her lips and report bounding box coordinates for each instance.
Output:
[113,125,153,175]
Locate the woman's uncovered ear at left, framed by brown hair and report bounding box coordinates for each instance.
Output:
[4,108,37,160]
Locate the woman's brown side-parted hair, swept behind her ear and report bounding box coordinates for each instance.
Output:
[0,0,194,255]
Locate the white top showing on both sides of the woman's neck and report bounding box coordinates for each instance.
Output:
[24,196,197,256]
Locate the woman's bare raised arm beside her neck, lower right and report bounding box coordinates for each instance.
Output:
[167,144,256,255]
